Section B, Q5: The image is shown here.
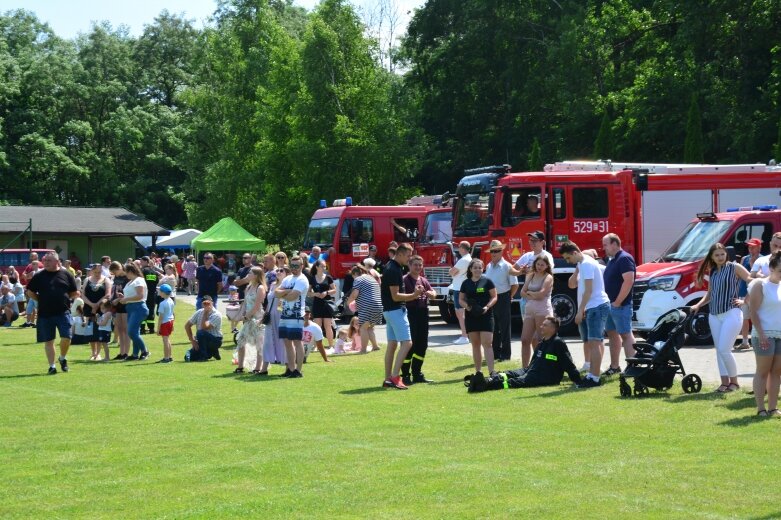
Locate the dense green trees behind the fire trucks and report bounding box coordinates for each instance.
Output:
[0,0,781,247]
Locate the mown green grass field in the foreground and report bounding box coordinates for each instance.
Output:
[0,298,781,519]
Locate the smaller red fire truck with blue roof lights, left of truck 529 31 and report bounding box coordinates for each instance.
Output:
[303,196,452,306]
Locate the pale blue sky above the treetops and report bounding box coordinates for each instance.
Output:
[0,0,425,38]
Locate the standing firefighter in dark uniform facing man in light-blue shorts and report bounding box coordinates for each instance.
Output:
[401,255,437,385]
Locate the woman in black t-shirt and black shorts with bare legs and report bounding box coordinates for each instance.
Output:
[458,258,499,375]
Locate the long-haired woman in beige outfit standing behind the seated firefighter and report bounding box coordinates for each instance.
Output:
[521,255,553,368]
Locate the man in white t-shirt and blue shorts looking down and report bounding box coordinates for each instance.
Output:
[559,242,610,388]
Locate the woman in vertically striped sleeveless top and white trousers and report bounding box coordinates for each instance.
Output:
[691,242,750,392]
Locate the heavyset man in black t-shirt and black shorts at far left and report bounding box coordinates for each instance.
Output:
[27,253,81,375]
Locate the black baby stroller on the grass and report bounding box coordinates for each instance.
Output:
[619,307,702,397]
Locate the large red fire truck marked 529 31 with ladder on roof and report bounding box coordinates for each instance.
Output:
[444,161,781,332]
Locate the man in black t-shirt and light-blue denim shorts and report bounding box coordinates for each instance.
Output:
[380,243,425,390]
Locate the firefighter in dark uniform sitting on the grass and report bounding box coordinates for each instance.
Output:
[465,316,580,393]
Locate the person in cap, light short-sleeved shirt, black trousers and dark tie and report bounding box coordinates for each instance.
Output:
[485,240,518,361]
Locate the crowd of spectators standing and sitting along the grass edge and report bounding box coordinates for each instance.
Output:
[6,231,781,416]
